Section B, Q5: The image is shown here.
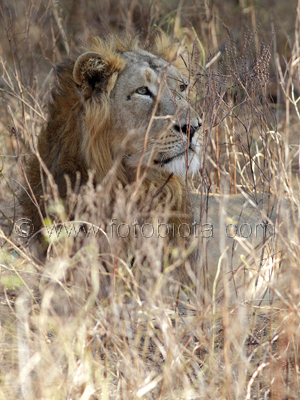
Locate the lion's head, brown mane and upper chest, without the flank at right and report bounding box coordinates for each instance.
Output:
[22,34,204,306]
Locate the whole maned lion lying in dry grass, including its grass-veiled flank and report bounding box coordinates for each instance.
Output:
[22,35,294,310]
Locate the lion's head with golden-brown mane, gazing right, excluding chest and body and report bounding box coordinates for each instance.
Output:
[24,37,201,238]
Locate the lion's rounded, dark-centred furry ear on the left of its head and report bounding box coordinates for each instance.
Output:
[73,52,125,98]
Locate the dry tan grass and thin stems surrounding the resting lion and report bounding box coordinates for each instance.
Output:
[0,0,300,400]
